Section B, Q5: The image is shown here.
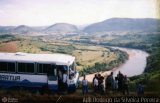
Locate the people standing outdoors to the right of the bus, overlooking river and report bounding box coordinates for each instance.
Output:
[82,71,144,95]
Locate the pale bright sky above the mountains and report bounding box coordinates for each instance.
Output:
[0,0,157,26]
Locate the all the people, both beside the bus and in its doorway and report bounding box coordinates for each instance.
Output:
[58,68,144,95]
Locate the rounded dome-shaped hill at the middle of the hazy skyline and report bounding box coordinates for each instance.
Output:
[44,23,78,33]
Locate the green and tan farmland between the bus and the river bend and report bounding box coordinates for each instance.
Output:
[0,35,127,71]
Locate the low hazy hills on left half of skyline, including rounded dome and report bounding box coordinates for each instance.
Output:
[0,23,79,35]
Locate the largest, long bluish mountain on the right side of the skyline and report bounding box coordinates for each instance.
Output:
[83,18,160,33]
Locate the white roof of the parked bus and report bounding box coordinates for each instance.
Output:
[0,52,75,65]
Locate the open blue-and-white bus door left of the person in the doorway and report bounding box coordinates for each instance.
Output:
[47,64,58,91]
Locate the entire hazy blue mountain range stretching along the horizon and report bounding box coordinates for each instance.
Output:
[0,18,160,34]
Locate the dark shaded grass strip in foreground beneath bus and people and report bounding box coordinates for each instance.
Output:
[0,89,160,103]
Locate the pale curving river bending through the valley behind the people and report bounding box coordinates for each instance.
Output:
[80,47,149,82]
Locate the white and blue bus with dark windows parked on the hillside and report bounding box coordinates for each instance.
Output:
[0,52,79,91]
